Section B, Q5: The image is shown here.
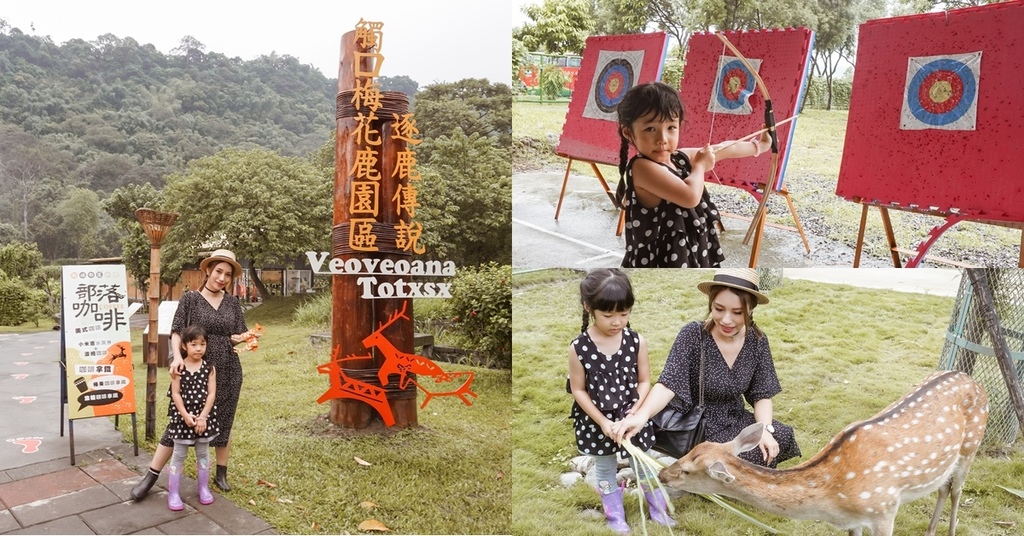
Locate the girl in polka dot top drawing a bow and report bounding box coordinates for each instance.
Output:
[615,82,771,267]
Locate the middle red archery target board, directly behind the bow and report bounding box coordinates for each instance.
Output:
[679,28,814,190]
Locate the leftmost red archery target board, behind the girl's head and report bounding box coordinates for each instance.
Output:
[555,32,669,164]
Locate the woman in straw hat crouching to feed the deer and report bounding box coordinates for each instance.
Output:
[615,269,800,467]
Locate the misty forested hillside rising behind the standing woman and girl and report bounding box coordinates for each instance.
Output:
[0,24,430,259]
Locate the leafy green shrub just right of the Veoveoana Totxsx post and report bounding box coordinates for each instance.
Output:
[449,262,512,369]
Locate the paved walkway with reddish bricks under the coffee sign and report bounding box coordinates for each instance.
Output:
[0,331,275,534]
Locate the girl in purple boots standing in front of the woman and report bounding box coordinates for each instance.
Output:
[166,326,219,511]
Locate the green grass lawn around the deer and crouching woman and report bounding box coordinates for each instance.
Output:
[512,270,1024,536]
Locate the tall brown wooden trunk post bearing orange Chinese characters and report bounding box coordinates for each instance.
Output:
[330,31,418,429]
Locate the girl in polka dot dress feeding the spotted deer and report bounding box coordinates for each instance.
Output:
[569,269,676,534]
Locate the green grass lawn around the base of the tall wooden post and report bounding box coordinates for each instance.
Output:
[121,298,512,534]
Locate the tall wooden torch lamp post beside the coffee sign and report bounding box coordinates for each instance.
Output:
[135,208,178,440]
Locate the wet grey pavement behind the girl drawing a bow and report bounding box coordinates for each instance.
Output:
[512,170,892,272]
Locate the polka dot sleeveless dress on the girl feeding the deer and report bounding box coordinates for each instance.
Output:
[569,328,654,457]
